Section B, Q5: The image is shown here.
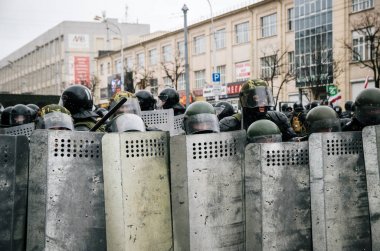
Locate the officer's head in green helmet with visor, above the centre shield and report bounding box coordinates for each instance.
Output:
[183,101,220,134]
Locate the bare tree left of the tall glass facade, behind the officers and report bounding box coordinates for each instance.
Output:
[261,49,295,107]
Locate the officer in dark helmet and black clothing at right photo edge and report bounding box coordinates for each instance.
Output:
[343,88,380,131]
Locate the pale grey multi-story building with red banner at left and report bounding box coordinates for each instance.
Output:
[0,19,150,95]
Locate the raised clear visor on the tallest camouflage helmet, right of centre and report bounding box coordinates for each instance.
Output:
[240,86,274,108]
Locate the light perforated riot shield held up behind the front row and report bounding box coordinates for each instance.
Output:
[141,109,174,134]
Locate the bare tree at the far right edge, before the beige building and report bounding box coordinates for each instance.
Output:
[344,11,380,88]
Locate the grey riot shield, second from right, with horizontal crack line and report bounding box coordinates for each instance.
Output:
[309,132,371,250]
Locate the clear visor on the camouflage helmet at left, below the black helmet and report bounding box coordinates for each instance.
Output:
[43,112,74,131]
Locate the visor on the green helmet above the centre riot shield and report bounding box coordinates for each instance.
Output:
[183,113,220,134]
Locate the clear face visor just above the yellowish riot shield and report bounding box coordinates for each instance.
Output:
[109,113,146,132]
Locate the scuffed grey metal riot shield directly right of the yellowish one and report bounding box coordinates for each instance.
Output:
[170,131,246,250]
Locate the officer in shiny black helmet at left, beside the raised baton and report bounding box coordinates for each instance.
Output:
[59,85,105,132]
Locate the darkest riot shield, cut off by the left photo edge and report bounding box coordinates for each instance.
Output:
[0,135,29,251]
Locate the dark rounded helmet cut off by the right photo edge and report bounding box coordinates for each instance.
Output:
[354,88,380,126]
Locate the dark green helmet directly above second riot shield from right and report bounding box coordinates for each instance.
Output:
[306,106,340,133]
